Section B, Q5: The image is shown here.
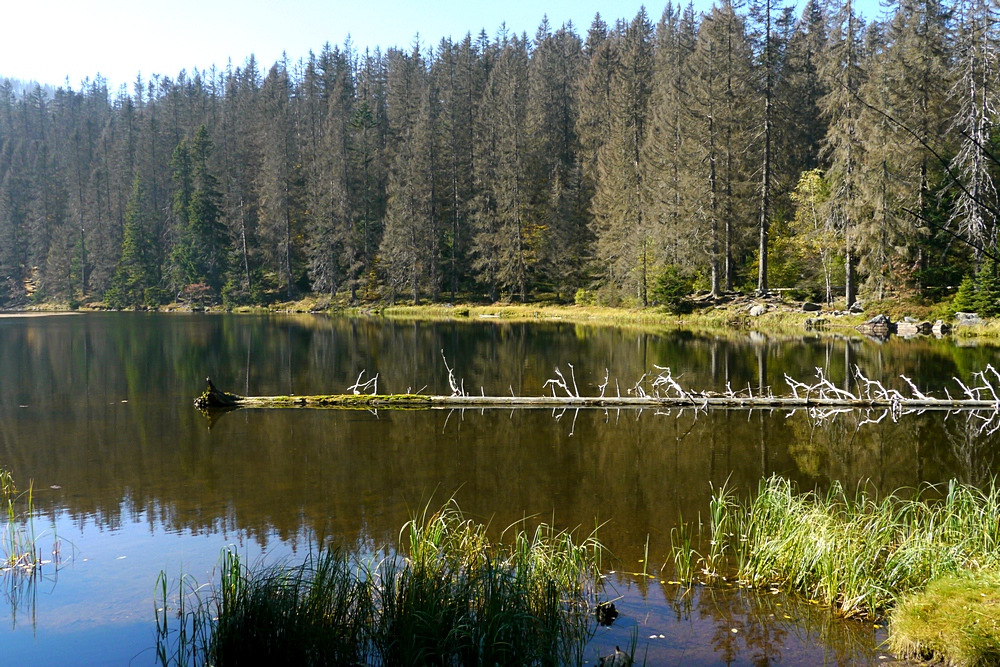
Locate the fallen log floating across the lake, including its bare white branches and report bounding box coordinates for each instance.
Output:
[189,366,1000,417]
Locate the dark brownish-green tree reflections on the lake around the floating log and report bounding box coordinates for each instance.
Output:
[0,314,997,559]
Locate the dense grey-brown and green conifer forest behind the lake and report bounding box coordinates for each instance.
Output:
[0,0,1000,308]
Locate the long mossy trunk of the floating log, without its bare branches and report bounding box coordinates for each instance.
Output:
[194,378,1000,411]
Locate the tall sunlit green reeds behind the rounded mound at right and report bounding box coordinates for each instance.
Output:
[674,477,1000,617]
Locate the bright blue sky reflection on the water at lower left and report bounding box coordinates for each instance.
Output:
[0,510,290,665]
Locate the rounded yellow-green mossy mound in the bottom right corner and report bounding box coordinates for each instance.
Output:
[889,572,1000,666]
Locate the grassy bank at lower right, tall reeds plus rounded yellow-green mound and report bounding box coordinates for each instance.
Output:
[673,477,1000,665]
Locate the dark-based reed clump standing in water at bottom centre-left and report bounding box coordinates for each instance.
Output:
[156,503,601,665]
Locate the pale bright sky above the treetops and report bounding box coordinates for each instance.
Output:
[0,0,876,89]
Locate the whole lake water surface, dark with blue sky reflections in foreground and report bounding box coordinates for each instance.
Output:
[0,314,1000,665]
